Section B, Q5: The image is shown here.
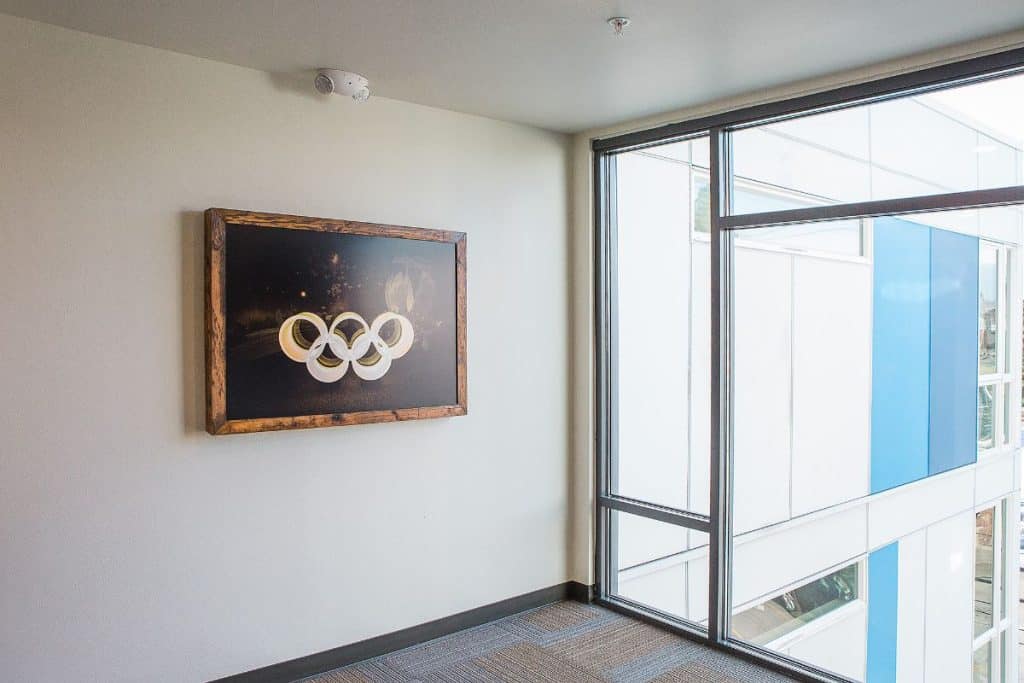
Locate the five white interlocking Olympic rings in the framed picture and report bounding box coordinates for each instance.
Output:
[278,311,414,383]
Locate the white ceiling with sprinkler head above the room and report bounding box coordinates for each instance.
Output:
[0,0,1024,131]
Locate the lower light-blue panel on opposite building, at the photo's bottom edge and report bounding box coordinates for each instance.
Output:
[866,543,899,683]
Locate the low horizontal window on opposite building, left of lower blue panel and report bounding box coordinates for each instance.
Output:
[732,564,861,645]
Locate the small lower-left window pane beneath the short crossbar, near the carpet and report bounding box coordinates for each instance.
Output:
[610,510,708,624]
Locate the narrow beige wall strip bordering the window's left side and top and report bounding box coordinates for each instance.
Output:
[569,31,1024,584]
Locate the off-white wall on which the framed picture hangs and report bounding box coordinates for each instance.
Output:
[0,16,569,682]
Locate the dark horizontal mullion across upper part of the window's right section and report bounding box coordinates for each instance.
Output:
[719,185,1024,230]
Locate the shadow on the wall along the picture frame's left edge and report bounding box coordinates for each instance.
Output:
[178,211,206,434]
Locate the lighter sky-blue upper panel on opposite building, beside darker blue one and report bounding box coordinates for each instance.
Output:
[871,218,931,494]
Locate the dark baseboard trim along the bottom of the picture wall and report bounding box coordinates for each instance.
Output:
[211,581,594,683]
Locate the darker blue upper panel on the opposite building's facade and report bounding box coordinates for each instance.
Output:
[928,229,978,474]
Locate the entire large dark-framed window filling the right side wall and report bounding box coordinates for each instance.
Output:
[594,52,1024,683]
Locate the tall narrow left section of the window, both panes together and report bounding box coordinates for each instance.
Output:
[603,136,711,628]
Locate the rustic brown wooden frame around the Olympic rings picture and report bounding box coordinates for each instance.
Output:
[205,209,468,434]
